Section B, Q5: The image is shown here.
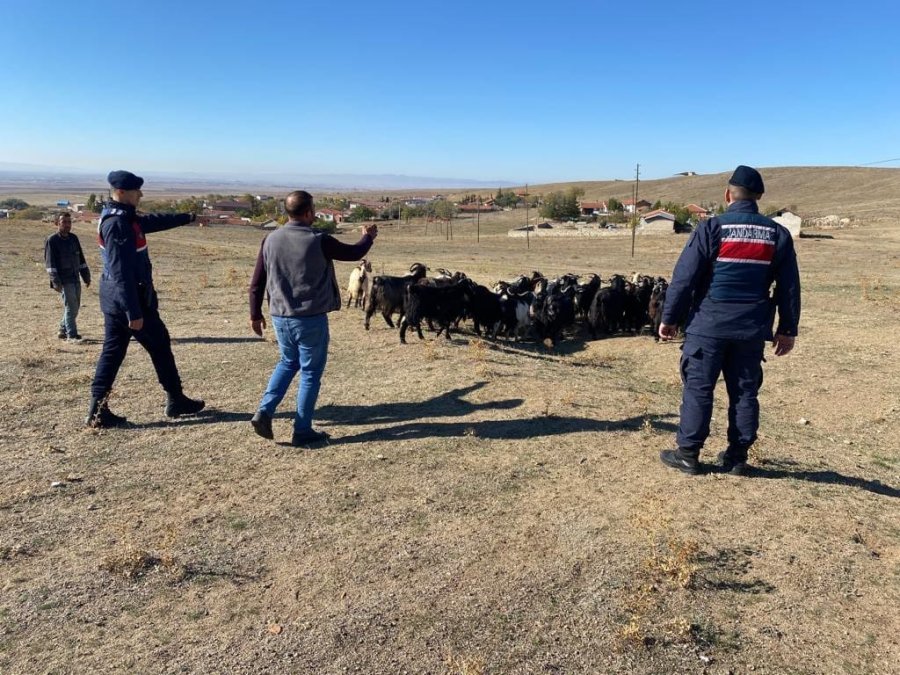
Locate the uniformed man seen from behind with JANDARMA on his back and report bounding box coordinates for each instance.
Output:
[659,166,800,475]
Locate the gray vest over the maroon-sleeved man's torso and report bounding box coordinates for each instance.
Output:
[263,223,341,316]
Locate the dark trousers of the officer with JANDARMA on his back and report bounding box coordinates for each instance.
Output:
[676,334,765,459]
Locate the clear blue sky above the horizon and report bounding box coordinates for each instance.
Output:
[0,0,900,183]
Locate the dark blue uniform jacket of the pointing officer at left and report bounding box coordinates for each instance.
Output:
[97,201,192,321]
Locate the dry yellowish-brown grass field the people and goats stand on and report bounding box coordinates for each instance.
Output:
[0,210,900,675]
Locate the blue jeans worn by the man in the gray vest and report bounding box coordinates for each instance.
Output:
[259,314,328,433]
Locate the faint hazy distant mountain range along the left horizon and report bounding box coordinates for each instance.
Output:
[0,162,517,190]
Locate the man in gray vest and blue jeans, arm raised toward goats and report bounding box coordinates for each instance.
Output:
[250,190,378,447]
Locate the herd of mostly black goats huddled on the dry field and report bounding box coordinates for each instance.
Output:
[347,260,668,347]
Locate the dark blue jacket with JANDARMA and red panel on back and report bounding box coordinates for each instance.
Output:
[662,201,800,340]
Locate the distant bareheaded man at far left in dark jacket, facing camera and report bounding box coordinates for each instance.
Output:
[44,213,91,342]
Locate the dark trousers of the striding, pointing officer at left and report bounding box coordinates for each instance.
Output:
[91,303,181,398]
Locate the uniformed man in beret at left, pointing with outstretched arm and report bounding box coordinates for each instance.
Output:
[85,171,205,428]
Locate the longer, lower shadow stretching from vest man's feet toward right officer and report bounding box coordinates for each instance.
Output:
[330,415,675,445]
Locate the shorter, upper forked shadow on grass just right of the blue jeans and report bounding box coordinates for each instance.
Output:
[316,382,525,425]
